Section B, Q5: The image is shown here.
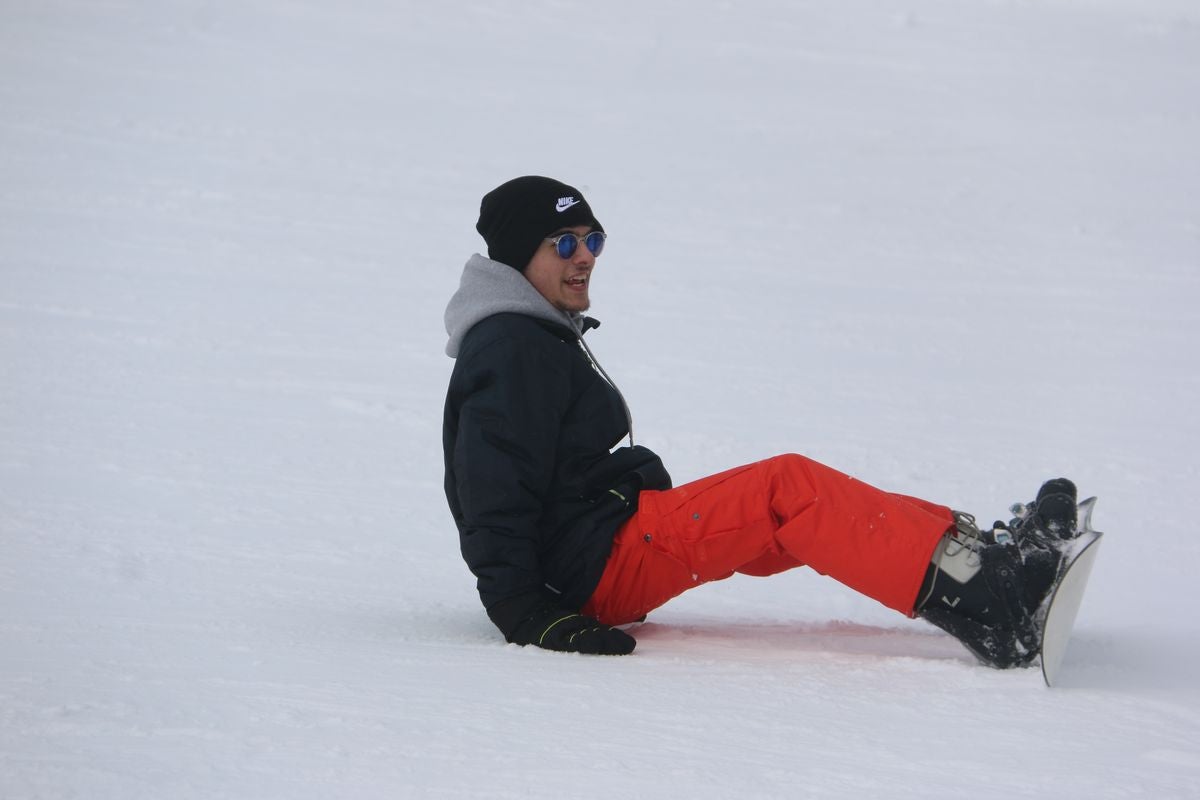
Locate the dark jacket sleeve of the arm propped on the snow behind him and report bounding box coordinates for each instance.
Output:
[452,338,570,637]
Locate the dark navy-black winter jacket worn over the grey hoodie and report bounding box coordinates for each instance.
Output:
[442,311,671,636]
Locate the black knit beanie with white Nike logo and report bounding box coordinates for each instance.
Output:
[475,175,604,271]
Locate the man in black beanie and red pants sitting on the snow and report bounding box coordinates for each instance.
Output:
[443,176,1075,667]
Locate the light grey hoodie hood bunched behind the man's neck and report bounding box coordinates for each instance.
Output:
[444,253,588,359]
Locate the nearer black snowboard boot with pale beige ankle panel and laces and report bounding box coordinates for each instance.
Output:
[916,511,1049,669]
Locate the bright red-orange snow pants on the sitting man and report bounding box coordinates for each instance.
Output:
[583,455,954,625]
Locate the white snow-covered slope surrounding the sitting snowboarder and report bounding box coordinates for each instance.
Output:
[0,0,1200,800]
